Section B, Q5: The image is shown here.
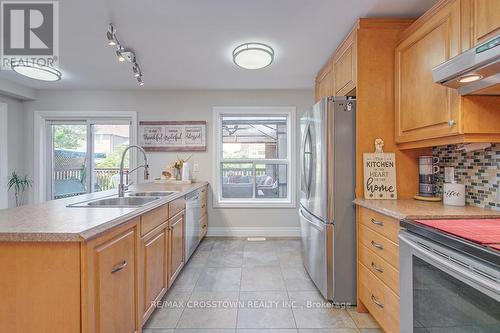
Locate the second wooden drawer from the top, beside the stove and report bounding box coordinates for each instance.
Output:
[359,225,399,269]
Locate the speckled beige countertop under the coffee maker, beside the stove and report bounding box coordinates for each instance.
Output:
[353,198,500,220]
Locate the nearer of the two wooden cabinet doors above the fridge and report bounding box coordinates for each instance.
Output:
[333,29,357,96]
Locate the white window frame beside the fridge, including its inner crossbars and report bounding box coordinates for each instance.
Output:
[212,106,297,208]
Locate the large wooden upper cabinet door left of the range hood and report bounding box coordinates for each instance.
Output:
[395,1,461,142]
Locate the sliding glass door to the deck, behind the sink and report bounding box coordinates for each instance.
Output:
[47,120,130,199]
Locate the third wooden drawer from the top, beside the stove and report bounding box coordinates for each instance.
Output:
[358,244,399,295]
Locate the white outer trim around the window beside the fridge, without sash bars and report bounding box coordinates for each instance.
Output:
[212,106,297,208]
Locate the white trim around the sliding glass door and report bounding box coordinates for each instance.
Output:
[33,111,137,203]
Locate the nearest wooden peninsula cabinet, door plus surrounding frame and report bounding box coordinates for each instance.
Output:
[82,219,141,333]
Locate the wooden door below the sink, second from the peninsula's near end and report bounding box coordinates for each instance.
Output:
[142,223,168,318]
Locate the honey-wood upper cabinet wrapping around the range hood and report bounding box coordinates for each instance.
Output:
[395,0,500,149]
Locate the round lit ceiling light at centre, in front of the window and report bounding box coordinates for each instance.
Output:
[233,43,274,69]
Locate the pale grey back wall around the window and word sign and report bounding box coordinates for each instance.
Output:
[24,90,314,236]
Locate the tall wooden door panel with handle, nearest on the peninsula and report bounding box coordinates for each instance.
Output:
[93,229,136,333]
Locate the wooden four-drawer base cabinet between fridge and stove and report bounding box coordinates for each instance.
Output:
[356,207,399,332]
